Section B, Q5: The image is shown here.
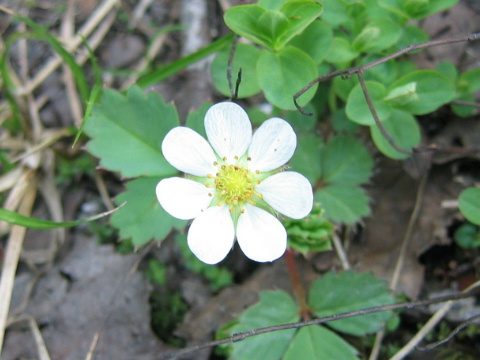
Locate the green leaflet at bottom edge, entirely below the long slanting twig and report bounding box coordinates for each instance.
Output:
[283,325,359,360]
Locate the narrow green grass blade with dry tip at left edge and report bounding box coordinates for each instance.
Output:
[0,204,119,230]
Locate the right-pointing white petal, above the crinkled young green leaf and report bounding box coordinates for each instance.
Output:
[255,171,313,219]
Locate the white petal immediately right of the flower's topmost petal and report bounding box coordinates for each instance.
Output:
[248,118,297,171]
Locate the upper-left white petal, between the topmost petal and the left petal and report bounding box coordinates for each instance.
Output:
[162,126,217,176]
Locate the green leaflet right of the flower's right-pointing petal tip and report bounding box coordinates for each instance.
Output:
[315,184,370,225]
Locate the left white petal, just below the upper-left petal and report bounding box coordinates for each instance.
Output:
[156,177,212,220]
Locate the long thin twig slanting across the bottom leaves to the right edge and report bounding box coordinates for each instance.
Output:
[152,287,480,360]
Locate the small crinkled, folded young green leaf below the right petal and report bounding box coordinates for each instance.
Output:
[283,204,335,254]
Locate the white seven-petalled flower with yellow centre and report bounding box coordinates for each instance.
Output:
[156,102,313,264]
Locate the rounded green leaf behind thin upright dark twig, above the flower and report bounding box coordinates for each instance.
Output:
[211,44,261,99]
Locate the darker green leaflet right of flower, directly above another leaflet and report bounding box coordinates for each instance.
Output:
[322,135,373,184]
